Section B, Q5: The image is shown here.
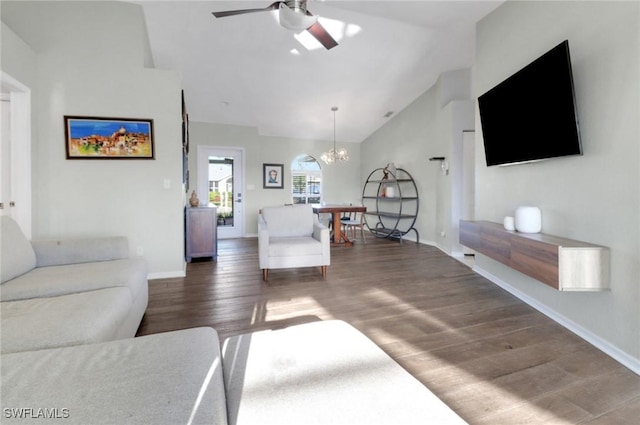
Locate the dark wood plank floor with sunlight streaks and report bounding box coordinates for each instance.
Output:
[138,237,640,425]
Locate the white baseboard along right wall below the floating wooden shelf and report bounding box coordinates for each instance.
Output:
[473,266,640,375]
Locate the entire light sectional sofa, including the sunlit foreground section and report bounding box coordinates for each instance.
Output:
[0,217,465,425]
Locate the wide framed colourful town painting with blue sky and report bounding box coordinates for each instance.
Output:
[64,115,155,159]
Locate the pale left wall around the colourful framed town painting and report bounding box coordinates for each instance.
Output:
[2,2,184,277]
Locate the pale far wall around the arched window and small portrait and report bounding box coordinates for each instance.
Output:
[186,120,364,235]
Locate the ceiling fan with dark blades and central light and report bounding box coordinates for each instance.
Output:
[212,0,338,50]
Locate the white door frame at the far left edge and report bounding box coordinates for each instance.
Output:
[0,71,32,239]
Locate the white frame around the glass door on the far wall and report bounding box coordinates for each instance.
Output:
[196,145,245,239]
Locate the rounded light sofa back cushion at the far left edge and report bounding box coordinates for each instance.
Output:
[0,215,36,283]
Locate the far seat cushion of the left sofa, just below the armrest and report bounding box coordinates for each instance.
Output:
[0,257,147,301]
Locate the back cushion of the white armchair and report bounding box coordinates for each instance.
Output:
[262,204,314,238]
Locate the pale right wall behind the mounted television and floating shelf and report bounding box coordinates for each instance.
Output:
[475,2,640,373]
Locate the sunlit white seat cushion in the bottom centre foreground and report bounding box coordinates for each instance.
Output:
[222,321,465,425]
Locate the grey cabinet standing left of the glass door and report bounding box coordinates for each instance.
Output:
[185,207,218,263]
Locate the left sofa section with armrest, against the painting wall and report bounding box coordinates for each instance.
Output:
[0,216,148,353]
